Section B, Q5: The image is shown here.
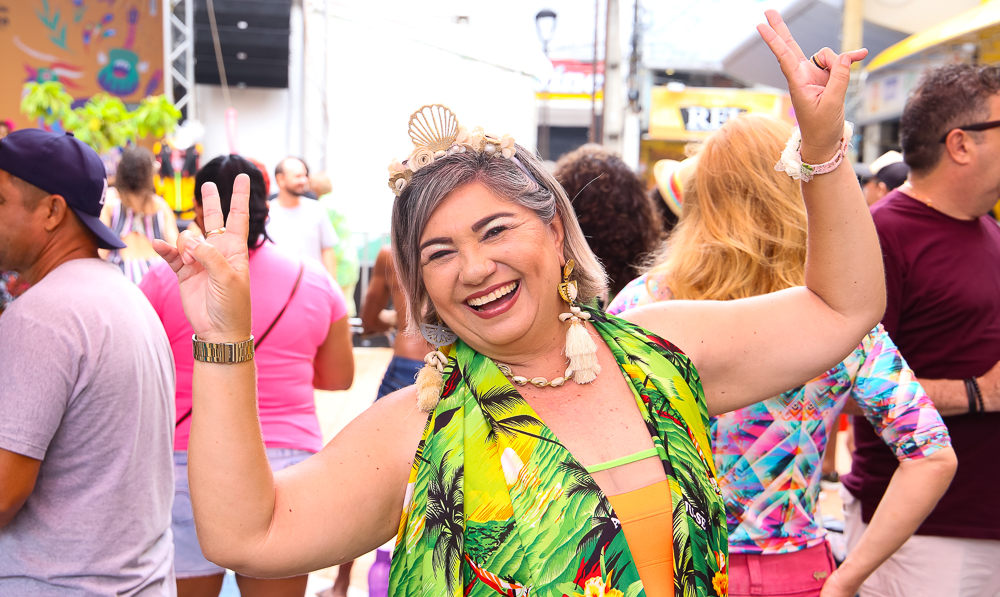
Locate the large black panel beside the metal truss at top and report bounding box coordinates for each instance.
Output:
[194,0,292,88]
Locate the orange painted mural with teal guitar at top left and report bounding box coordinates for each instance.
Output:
[0,0,163,128]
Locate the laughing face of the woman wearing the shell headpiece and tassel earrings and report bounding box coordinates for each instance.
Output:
[420,183,565,357]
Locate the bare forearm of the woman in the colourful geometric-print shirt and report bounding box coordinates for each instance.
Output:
[822,447,958,597]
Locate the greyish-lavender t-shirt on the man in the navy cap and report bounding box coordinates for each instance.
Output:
[0,259,176,596]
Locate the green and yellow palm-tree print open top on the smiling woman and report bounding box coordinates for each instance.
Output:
[389,309,728,597]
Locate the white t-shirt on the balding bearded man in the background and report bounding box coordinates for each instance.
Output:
[266,197,340,263]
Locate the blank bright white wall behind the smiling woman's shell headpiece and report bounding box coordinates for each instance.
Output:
[326,5,537,233]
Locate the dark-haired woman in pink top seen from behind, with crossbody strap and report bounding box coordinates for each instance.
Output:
[140,155,354,597]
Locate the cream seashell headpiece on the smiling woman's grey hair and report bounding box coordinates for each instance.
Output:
[389,104,517,197]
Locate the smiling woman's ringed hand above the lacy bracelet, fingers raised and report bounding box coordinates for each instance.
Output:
[757,10,868,164]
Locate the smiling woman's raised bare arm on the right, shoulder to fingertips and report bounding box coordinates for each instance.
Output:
[626,11,885,414]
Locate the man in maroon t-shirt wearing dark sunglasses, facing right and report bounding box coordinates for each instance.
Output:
[842,64,1000,597]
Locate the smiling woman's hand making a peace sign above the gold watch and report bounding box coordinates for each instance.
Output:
[153,174,250,342]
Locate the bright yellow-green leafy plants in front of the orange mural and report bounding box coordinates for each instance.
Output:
[21,81,181,153]
